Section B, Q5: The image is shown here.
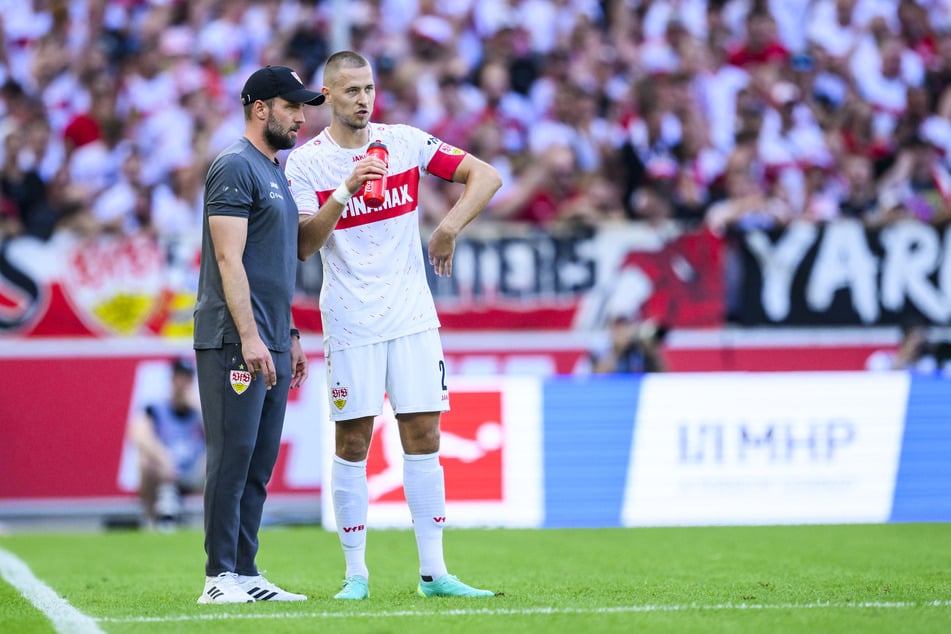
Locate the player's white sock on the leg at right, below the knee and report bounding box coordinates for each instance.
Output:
[403,453,447,579]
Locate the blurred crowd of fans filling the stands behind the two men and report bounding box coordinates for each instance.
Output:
[0,0,951,244]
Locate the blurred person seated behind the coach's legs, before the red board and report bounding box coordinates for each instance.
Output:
[128,358,205,530]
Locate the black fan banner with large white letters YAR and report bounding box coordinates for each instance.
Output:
[734,220,951,326]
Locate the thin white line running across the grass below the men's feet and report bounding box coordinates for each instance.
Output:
[99,601,951,623]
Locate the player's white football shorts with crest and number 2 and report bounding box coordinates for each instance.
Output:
[324,328,449,422]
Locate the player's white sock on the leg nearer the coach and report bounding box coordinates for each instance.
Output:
[330,455,370,579]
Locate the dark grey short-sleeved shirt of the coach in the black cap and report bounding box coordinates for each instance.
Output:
[195,138,297,352]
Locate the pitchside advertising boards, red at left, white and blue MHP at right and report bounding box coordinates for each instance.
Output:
[0,341,951,528]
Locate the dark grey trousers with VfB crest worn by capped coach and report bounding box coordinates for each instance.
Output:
[195,344,291,577]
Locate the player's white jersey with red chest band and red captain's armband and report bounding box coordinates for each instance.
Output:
[285,123,465,350]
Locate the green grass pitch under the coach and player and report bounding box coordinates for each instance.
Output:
[0,524,951,634]
